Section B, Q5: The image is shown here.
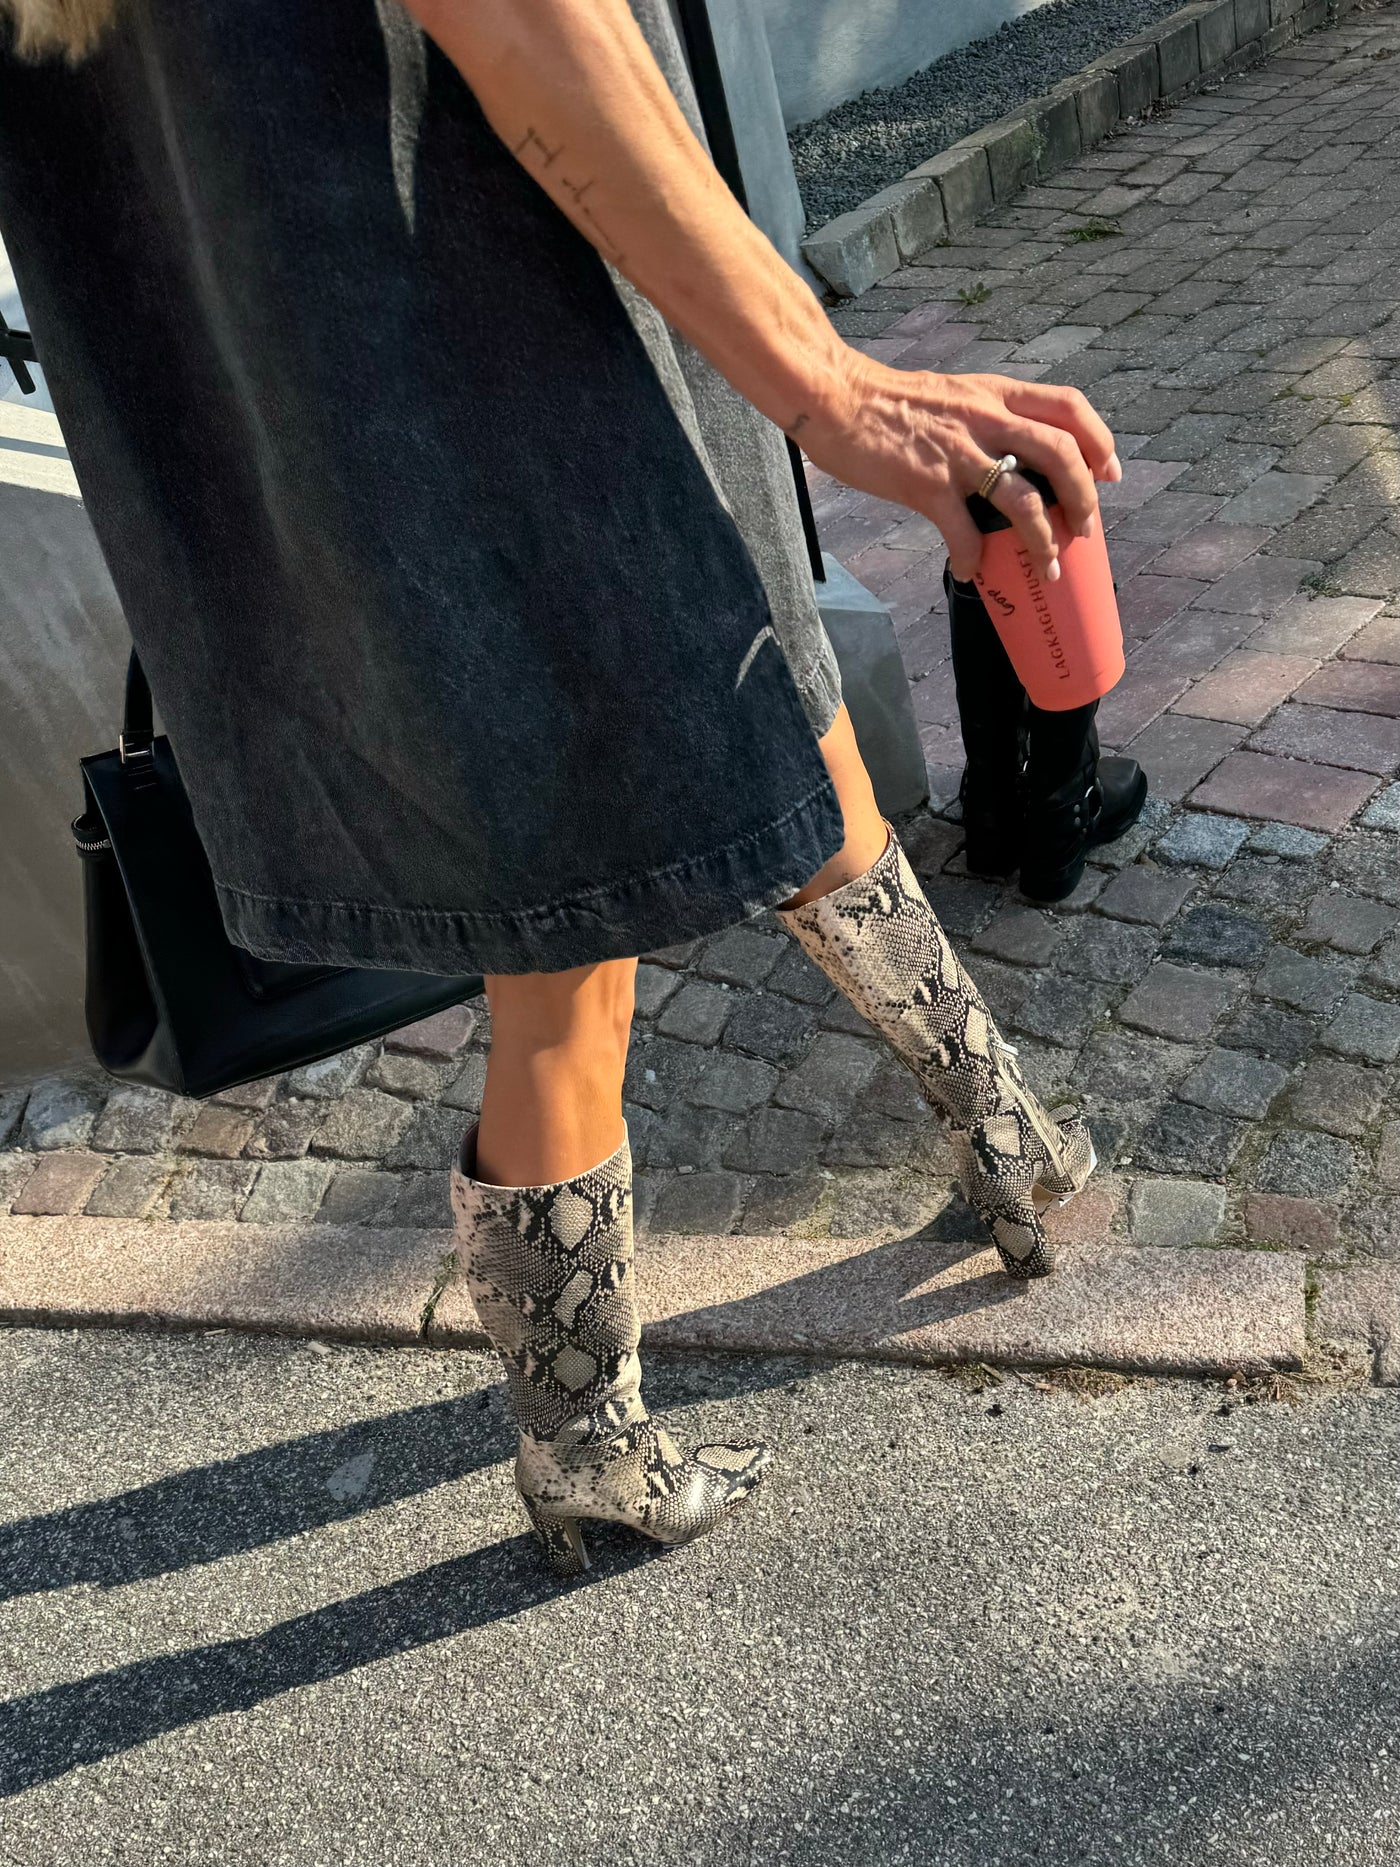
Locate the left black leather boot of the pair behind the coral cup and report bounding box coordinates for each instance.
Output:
[943,566,1029,876]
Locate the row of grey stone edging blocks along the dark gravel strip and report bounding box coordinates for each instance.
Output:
[803,0,1357,299]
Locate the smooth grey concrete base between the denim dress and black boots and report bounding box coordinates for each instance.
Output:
[816,553,928,816]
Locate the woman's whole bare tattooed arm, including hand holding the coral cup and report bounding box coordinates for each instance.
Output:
[405,0,1120,579]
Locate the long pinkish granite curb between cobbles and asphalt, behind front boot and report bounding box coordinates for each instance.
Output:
[0,1219,1305,1374]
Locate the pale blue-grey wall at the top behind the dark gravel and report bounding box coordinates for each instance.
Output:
[752,0,1049,125]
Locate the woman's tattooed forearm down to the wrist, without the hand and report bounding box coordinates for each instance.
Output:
[407,0,846,433]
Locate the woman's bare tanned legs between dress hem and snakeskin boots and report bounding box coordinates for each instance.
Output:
[476,708,885,1186]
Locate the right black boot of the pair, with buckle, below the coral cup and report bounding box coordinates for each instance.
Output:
[1021,700,1148,902]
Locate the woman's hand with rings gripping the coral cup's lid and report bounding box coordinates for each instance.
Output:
[788,351,1122,583]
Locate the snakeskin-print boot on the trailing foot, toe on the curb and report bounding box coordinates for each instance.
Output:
[780,831,1096,1277]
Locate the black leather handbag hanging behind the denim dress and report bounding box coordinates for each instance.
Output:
[73,653,482,1096]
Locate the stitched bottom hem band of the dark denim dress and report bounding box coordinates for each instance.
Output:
[217,779,846,973]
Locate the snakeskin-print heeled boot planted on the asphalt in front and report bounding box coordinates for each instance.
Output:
[452,1128,769,1576]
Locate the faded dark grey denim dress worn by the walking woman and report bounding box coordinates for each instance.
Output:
[0,0,842,971]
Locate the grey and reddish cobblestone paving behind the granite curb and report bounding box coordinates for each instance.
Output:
[0,9,1400,1299]
